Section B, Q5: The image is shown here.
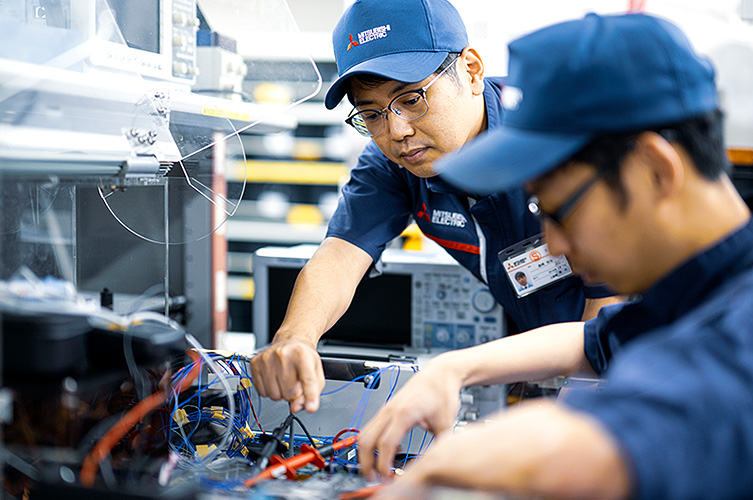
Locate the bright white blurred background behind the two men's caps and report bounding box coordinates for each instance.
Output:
[276,0,753,147]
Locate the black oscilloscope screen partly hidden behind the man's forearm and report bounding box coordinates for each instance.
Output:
[268,267,411,349]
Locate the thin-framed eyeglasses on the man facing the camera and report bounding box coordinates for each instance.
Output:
[345,57,458,137]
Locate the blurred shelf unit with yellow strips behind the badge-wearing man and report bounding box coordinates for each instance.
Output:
[226,60,364,333]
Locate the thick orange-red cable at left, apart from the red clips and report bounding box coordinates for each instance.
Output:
[81,350,201,487]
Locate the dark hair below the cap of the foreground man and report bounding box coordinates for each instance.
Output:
[560,109,731,206]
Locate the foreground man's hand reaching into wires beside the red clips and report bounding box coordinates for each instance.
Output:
[358,356,461,480]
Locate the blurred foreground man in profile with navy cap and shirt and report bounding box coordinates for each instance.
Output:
[359,14,753,500]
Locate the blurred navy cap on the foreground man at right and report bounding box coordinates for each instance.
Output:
[435,14,718,194]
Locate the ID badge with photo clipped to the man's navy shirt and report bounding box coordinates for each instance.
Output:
[497,234,573,298]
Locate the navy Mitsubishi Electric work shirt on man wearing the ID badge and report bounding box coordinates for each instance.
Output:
[327,78,612,331]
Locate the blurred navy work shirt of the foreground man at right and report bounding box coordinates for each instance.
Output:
[564,222,753,500]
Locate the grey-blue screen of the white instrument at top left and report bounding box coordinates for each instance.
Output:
[107,0,160,54]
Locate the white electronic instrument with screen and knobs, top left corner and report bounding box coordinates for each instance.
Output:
[0,0,199,84]
